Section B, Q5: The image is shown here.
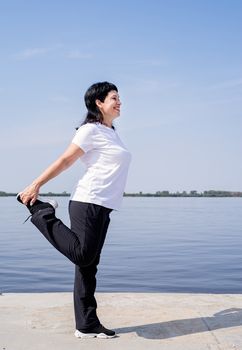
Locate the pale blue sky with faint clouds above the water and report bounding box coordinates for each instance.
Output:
[0,0,242,192]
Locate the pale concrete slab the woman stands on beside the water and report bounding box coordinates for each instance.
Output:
[0,293,242,350]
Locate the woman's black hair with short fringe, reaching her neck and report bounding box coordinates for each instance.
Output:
[82,81,118,129]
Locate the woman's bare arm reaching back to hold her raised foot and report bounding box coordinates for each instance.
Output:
[20,143,84,205]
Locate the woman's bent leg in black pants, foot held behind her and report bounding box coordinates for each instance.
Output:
[31,201,110,266]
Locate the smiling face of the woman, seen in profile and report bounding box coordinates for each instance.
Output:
[96,90,121,119]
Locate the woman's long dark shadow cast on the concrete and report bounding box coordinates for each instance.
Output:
[116,308,242,339]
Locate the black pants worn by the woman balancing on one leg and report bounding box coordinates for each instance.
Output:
[31,201,112,331]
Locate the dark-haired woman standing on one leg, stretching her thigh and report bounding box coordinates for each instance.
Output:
[17,82,131,338]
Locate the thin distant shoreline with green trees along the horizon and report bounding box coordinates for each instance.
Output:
[0,190,242,198]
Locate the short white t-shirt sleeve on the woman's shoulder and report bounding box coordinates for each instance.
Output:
[72,123,94,152]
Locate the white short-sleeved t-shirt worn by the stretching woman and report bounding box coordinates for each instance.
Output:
[71,123,131,210]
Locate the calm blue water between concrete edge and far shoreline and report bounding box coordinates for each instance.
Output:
[0,197,242,293]
